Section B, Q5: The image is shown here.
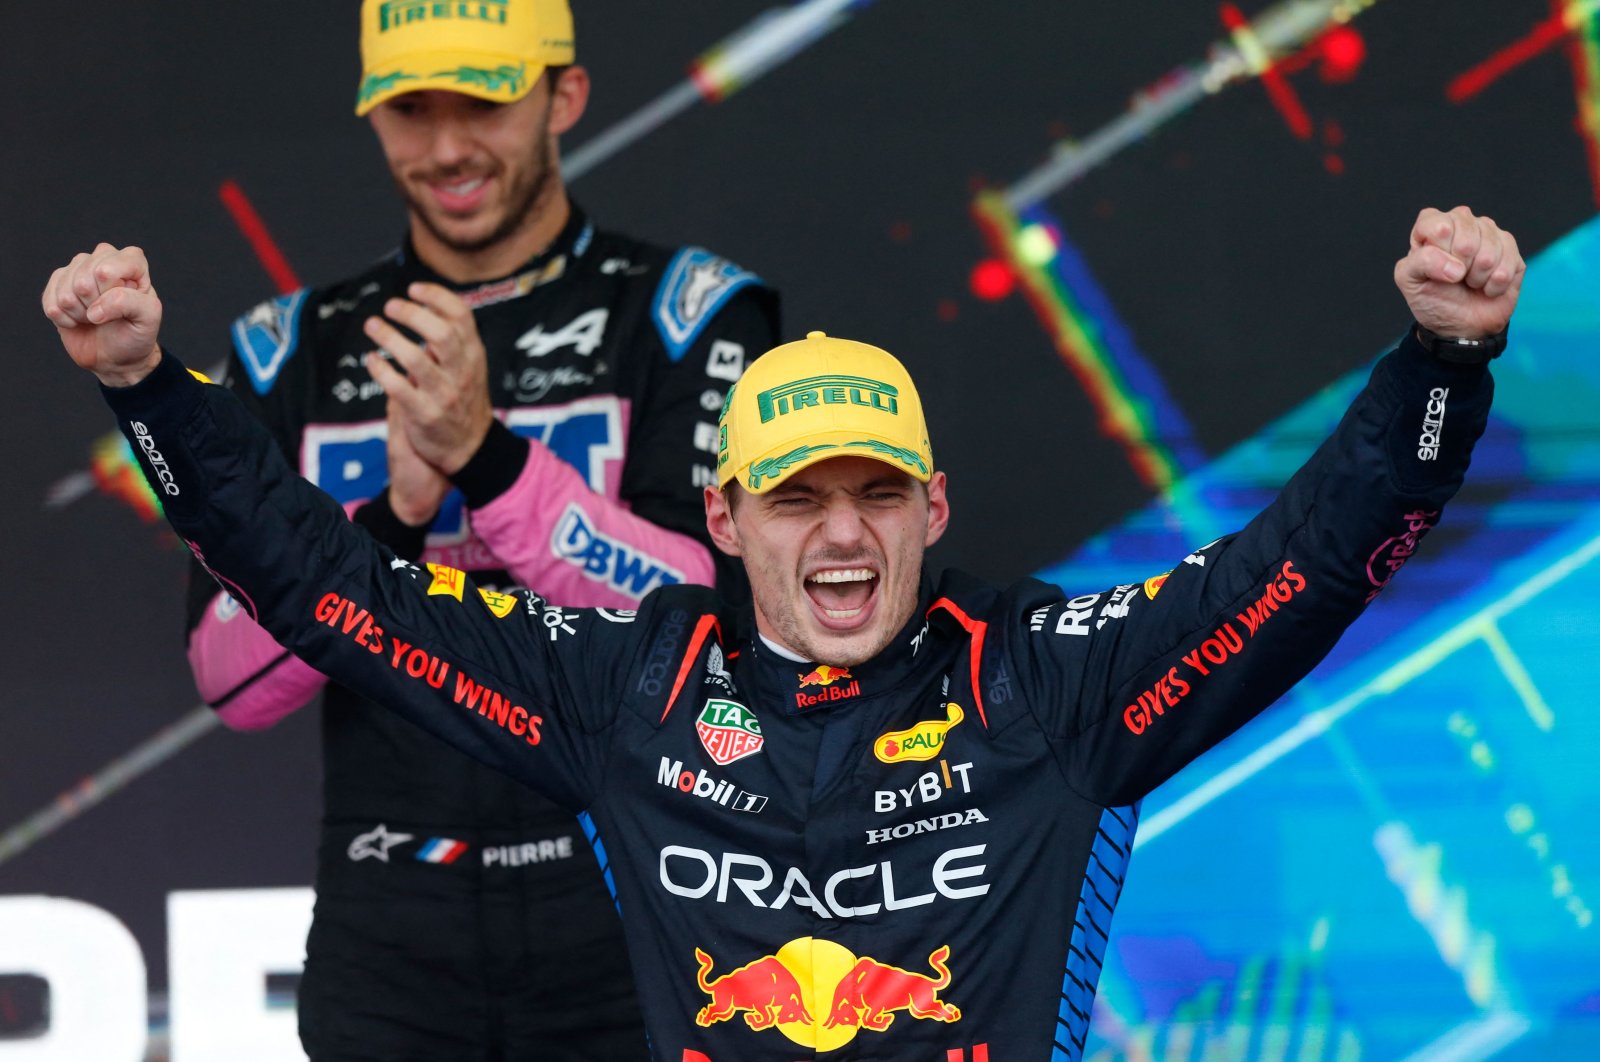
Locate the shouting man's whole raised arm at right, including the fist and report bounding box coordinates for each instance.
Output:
[1019,208,1523,804]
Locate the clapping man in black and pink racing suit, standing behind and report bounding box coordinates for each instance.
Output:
[189,0,776,1062]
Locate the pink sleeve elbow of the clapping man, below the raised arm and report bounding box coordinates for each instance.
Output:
[189,593,328,731]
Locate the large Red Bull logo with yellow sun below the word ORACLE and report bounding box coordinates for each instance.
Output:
[694,937,962,1052]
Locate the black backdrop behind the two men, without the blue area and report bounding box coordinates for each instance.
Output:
[0,0,1595,985]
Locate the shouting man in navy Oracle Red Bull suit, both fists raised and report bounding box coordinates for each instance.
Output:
[43,208,1523,1062]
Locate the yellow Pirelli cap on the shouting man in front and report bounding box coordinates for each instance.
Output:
[717,331,933,494]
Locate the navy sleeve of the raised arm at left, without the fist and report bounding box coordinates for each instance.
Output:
[106,348,601,808]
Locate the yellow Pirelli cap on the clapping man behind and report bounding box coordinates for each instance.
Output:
[355,0,576,115]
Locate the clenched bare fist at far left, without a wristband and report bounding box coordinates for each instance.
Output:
[42,243,162,387]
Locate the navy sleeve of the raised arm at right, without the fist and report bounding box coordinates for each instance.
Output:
[1069,327,1493,803]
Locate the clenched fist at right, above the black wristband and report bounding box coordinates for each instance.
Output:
[1395,206,1526,339]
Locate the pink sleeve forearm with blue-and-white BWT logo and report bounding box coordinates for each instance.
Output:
[470,443,715,608]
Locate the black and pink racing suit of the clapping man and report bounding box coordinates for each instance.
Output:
[189,208,778,1062]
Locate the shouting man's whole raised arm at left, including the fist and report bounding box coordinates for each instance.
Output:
[43,245,635,809]
